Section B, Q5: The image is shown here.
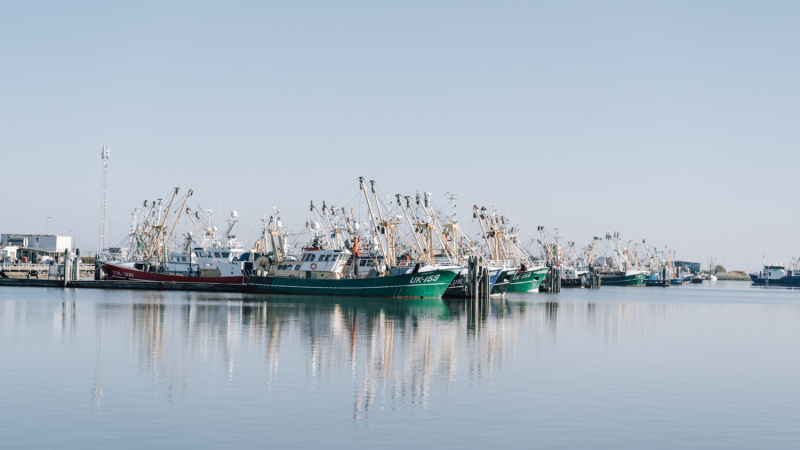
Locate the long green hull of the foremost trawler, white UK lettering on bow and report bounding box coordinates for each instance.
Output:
[248,270,456,298]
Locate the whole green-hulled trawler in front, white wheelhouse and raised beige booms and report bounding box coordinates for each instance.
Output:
[248,177,462,298]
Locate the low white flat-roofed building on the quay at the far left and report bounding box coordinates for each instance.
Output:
[0,233,72,264]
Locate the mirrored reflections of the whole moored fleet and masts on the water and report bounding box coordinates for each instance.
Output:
[1,292,678,419]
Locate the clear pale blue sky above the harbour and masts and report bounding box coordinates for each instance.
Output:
[0,1,800,271]
